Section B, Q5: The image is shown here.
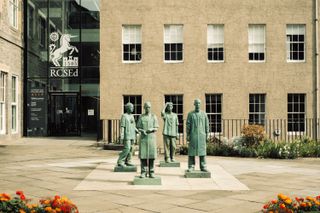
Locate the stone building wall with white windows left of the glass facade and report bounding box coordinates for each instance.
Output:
[0,0,23,141]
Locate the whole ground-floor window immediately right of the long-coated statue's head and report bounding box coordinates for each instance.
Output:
[206,94,222,133]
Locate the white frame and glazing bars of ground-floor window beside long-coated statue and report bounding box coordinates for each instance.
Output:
[205,93,223,135]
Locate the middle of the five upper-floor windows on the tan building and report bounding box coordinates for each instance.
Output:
[207,24,224,62]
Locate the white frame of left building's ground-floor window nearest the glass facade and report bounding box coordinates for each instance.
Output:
[11,75,19,133]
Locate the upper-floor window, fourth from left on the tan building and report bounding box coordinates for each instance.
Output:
[248,24,266,62]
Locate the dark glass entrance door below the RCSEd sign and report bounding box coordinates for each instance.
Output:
[49,93,80,136]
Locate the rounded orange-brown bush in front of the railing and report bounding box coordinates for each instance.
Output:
[241,125,265,147]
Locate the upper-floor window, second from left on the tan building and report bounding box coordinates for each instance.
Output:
[164,25,183,62]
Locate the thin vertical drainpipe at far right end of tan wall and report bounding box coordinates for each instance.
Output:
[314,0,320,139]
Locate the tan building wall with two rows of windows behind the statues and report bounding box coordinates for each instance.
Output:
[100,0,319,143]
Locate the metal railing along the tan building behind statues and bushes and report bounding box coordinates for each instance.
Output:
[102,118,320,145]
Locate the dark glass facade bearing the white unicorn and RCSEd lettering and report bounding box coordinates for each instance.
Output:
[24,0,100,136]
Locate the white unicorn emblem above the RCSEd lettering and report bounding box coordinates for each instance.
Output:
[49,32,79,67]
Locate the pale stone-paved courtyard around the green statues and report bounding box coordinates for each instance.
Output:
[0,138,320,213]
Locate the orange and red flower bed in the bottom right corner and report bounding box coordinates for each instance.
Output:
[262,194,320,213]
